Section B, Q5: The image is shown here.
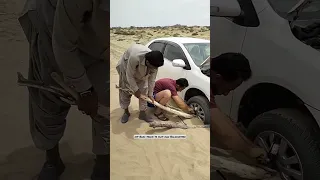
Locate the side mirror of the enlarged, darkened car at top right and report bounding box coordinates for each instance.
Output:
[210,0,241,17]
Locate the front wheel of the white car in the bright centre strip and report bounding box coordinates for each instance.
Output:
[187,96,210,124]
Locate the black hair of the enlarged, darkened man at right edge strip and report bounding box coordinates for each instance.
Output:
[210,53,252,82]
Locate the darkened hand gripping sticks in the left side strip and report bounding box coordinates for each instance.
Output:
[77,88,98,116]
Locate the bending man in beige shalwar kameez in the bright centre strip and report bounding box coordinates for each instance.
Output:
[116,44,164,123]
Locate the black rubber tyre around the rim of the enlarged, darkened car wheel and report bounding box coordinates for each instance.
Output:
[247,109,320,180]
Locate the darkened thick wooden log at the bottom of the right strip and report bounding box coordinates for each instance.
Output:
[210,148,278,180]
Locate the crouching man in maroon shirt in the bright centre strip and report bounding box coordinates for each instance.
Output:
[148,78,194,121]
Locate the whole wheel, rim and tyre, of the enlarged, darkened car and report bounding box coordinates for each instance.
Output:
[247,109,320,180]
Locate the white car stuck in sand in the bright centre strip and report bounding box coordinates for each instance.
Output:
[146,37,210,124]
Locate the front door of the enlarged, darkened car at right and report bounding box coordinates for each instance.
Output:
[210,0,259,118]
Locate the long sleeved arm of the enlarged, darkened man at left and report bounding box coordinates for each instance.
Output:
[52,0,92,92]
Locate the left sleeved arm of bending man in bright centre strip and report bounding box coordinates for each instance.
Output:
[126,56,139,92]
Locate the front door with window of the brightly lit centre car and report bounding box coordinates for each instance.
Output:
[159,42,189,79]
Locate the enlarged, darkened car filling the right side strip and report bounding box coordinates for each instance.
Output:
[210,0,320,180]
